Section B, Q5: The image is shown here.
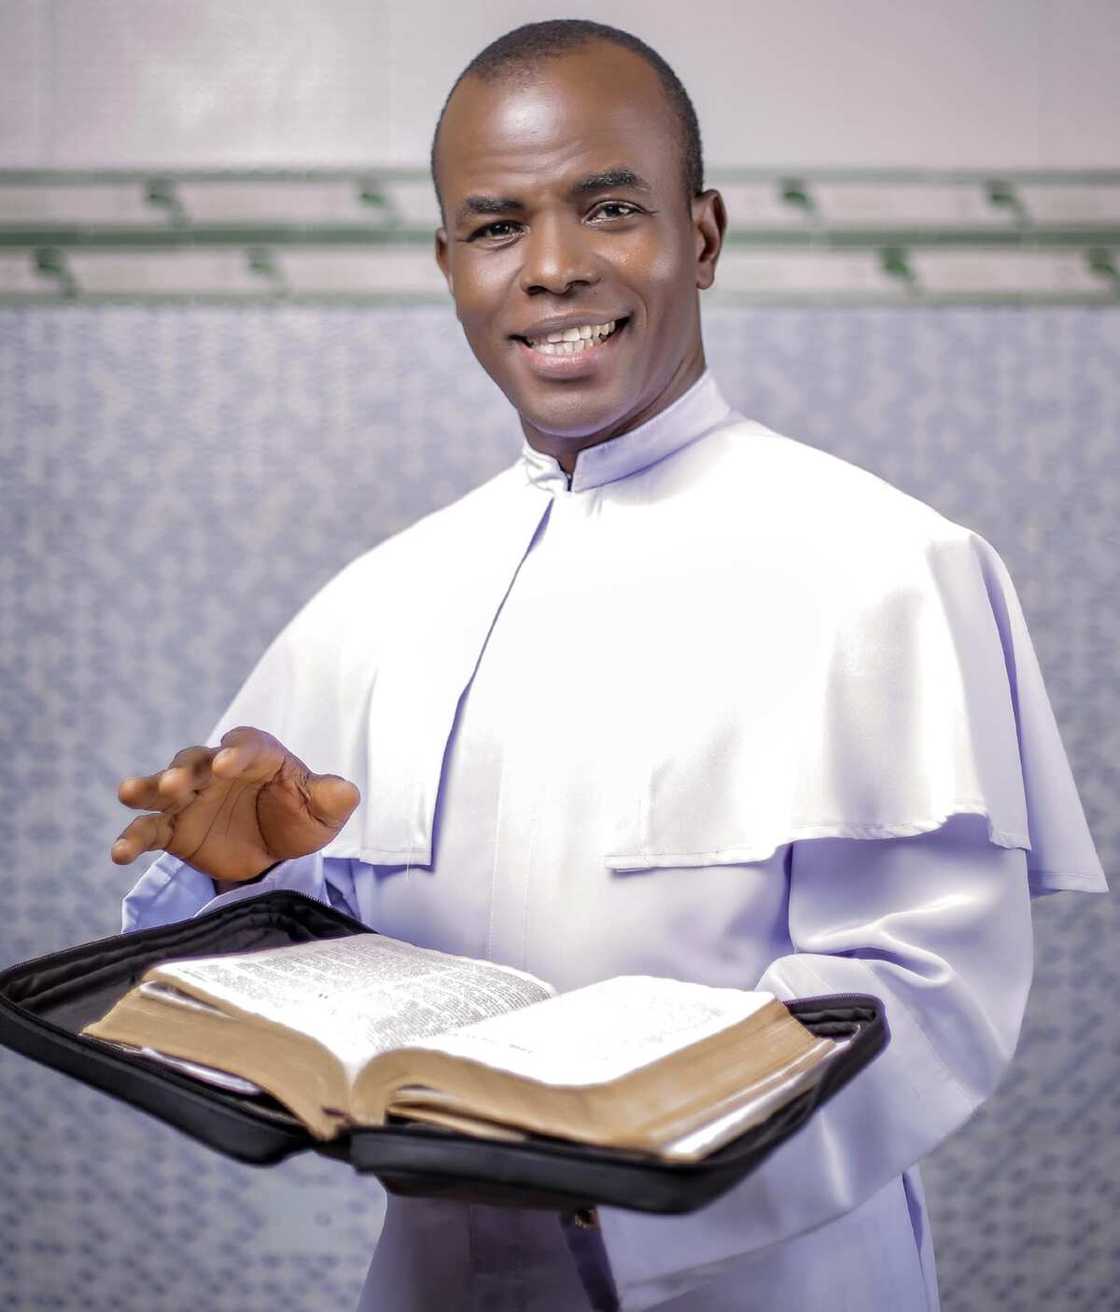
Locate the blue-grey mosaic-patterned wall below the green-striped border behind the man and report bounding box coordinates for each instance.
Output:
[0,307,1120,1312]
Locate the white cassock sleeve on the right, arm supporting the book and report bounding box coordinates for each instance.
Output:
[602,816,1032,1309]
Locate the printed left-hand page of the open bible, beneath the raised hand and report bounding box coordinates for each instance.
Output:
[150,934,553,1078]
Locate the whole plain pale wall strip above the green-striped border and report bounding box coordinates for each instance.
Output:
[0,0,1120,168]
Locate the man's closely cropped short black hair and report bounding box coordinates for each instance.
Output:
[429,18,704,209]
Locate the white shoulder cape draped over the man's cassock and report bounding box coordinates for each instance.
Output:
[210,420,1107,893]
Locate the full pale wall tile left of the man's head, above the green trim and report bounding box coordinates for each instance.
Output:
[43,0,388,168]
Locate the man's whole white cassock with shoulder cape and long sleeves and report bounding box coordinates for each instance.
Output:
[125,374,1106,1312]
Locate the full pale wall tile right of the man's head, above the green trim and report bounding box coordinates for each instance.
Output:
[694,0,1040,168]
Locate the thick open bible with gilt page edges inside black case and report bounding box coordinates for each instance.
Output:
[83,934,843,1162]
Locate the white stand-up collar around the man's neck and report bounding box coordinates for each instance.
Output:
[519,369,730,493]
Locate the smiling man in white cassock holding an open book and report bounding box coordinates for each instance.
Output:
[113,22,1104,1312]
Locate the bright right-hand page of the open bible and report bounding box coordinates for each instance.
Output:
[409,975,774,1085]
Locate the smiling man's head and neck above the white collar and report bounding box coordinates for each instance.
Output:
[433,29,725,474]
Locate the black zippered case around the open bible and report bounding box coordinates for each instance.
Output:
[0,891,889,1212]
